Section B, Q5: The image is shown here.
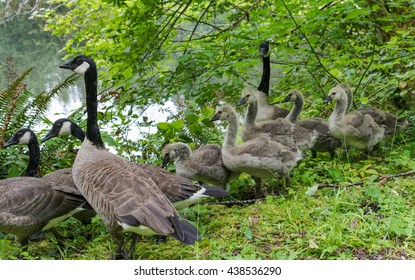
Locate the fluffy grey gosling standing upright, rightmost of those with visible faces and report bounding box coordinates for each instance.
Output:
[326,85,385,151]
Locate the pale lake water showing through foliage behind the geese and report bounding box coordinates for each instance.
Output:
[0,17,172,140]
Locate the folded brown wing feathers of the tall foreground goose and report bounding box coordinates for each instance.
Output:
[74,155,183,234]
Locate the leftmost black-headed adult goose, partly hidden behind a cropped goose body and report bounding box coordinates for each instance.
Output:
[5,128,96,225]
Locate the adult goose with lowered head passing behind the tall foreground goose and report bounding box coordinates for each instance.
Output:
[42,118,228,210]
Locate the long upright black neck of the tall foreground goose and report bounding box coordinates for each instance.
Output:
[84,67,104,148]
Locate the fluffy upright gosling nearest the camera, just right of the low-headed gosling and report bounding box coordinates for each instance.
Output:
[210,105,302,190]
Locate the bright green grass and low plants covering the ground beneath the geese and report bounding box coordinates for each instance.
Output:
[0,137,415,260]
